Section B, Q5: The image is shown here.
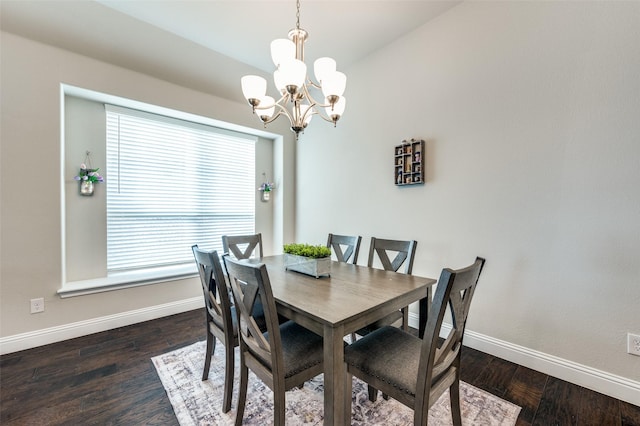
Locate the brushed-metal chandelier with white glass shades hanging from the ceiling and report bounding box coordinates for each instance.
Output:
[241,0,347,139]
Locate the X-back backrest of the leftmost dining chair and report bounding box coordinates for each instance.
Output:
[191,245,238,334]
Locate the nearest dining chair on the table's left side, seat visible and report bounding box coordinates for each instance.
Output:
[223,254,324,426]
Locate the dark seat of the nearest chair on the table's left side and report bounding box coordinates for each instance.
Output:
[262,321,324,378]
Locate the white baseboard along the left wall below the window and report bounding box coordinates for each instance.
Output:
[0,296,204,355]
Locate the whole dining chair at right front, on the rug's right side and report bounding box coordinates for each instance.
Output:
[344,257,485,426]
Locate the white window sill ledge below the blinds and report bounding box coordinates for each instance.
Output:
[58,264,198,299]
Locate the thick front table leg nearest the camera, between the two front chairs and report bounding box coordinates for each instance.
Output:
[324,325,351,426]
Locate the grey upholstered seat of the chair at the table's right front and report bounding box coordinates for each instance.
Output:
[344,326,423,396]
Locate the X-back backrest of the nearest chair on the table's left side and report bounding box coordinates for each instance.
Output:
[223,254,284,374]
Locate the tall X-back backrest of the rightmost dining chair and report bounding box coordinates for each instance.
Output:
[415,257,485,412]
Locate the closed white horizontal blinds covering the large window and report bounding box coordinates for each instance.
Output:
[106,105,256,272]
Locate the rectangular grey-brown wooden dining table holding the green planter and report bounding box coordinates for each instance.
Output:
[255,255,436,425]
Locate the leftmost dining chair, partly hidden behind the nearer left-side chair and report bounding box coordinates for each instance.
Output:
[191,245,238,413]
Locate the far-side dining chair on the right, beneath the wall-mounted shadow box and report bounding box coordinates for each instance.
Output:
[352,237,418,340]
